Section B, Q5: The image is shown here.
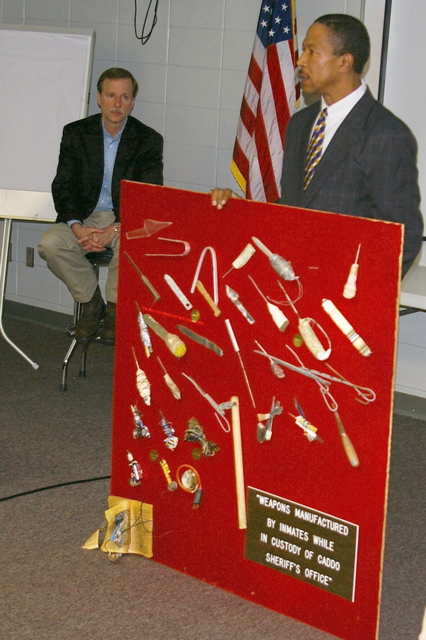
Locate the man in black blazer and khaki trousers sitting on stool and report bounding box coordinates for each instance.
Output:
[38,68,163,344]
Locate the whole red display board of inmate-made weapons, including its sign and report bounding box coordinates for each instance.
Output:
[111,182,403,640]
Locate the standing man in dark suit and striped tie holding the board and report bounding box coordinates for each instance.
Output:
[212,14,423,275]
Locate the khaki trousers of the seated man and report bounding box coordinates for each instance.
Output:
[38,211,120,302]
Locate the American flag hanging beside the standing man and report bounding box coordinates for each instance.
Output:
[231,0,300,202]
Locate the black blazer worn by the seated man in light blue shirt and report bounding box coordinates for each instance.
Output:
[52,113,163,222]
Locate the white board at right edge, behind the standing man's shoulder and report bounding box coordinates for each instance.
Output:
[383,0,426,232]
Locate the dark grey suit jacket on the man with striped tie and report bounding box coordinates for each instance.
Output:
[278,90,423,274]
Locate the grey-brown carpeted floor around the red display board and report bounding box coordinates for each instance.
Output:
[0,318,426,640]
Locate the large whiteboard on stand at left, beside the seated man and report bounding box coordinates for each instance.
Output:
[0,25,95,220]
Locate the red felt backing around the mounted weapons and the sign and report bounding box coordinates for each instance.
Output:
[111,182,402,640]
